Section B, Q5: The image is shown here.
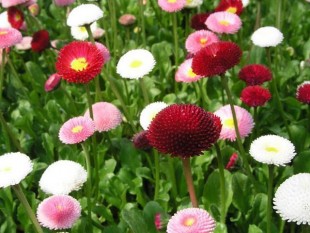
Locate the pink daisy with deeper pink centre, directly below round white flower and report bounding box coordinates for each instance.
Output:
[37,195,81,230]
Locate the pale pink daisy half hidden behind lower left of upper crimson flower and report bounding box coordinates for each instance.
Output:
[175,59,202,83]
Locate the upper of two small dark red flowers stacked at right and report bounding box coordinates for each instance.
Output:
[239,64,272,86]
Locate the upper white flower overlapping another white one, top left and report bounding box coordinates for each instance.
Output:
[67,4,103,27]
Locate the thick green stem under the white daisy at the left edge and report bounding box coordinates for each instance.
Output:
[12,184,43,233]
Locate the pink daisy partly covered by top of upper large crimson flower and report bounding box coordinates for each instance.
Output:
[185,30,219,54]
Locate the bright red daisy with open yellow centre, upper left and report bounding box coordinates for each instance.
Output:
[56,41,104,83]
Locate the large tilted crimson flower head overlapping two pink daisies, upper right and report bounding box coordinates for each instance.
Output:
[192,41,242,77]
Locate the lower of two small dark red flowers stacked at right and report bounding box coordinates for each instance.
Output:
[240,86,271,107]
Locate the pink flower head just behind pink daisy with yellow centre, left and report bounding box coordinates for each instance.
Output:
[84,102,122,132]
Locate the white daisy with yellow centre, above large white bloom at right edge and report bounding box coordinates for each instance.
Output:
[250,135,296,166]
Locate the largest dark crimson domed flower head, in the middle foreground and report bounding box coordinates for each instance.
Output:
[147,104,222,158]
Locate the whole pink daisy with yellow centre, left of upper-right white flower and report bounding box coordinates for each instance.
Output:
[205,11,242,34]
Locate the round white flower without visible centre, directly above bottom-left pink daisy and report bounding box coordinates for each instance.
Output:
[39,160,87,195]
